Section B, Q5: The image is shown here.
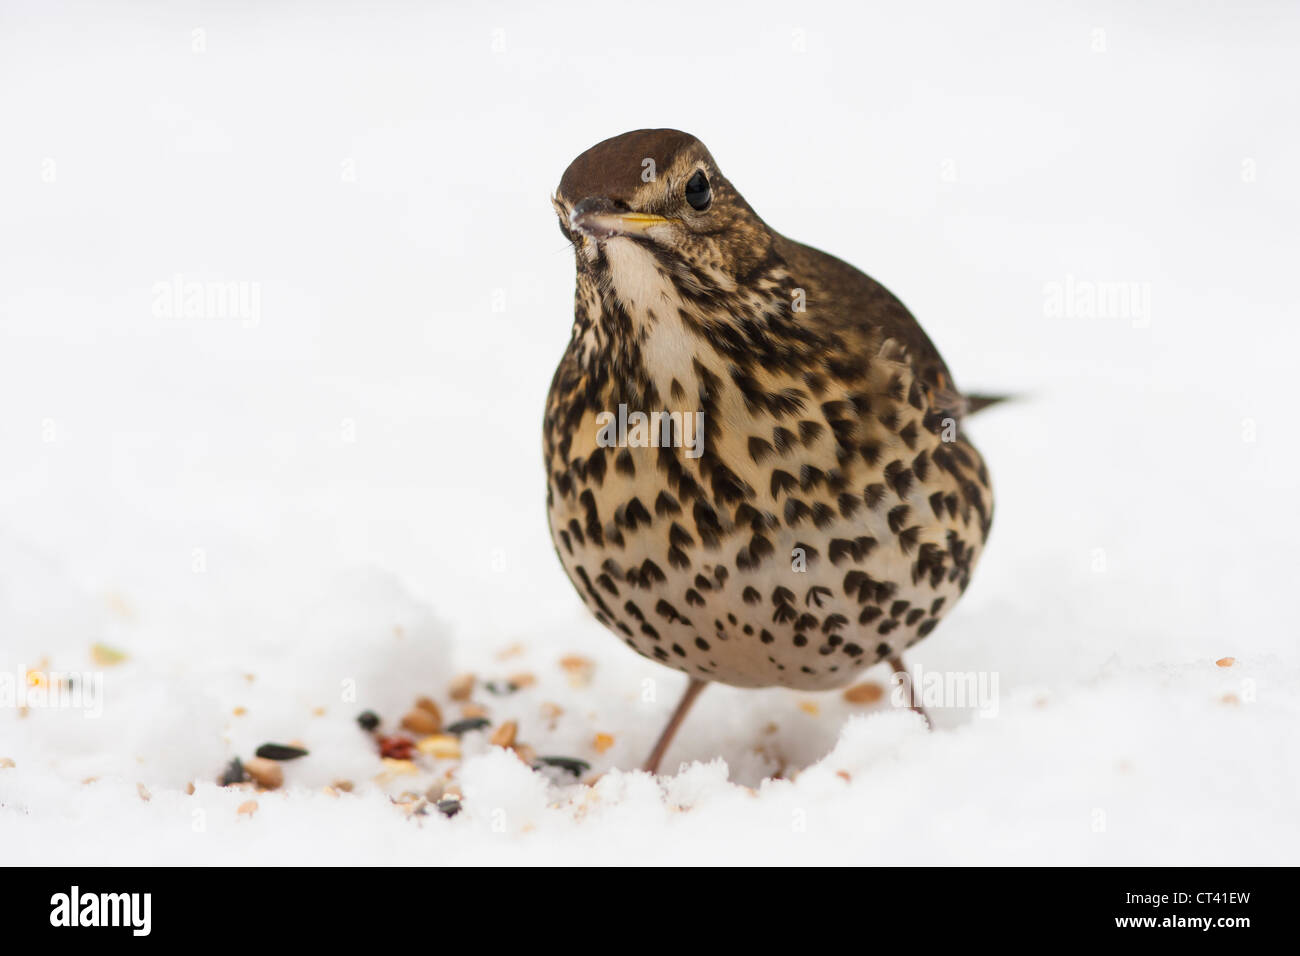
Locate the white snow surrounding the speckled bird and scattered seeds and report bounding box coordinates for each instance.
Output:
[0,0,1300,864]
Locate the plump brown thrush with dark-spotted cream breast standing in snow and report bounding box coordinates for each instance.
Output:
[542,129,997,773]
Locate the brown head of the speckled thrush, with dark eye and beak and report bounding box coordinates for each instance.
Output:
[553,130,772,290]
